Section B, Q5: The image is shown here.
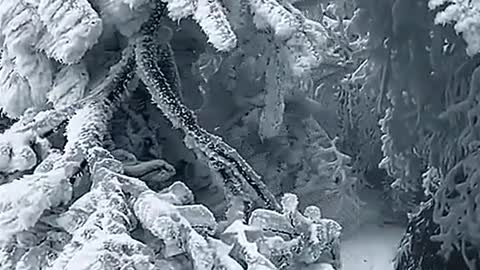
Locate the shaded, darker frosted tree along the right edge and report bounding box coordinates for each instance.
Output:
[349,0,480,270]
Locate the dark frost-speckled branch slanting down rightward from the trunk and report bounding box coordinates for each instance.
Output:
[136,3,279,212]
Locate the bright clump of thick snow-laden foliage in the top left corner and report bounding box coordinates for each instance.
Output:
[0,0,103,117]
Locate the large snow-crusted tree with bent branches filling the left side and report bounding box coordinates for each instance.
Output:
[0,0,348,270]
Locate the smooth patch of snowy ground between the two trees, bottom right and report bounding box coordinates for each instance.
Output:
[341,190,405,270]
